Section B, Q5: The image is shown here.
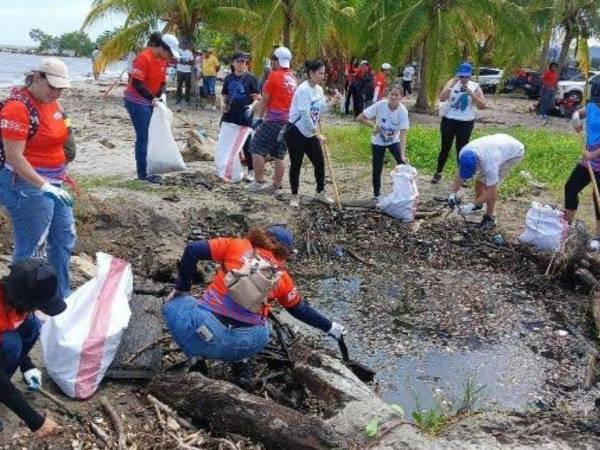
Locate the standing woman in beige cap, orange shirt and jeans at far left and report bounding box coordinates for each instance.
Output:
[0,58,75,297]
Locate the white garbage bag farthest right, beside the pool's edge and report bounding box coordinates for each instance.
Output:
[519,202,569,252]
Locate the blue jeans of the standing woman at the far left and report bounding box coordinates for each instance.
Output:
[0,168,76,298]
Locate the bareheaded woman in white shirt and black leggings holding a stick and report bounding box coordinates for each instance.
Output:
[285,60,339,208]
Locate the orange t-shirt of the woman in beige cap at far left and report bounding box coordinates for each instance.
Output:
[0,89,69,168]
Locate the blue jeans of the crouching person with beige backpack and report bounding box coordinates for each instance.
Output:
[163,295,269,361]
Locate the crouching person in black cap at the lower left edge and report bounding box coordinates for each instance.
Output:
[0,258,67,438]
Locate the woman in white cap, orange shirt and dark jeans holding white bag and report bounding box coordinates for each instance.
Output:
[125,34,179,183]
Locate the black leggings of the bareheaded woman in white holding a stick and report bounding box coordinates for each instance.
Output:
[285,125,325,195]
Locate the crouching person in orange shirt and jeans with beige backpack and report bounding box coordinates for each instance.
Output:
[163,225,344,385]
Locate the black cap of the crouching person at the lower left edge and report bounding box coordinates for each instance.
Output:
[6,258,67,316]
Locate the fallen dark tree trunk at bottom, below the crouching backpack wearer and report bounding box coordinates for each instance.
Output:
[149,373,339,450]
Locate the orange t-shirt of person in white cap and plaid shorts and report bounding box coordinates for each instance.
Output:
[263,69,298,122]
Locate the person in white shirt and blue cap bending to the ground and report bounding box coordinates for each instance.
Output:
[448,134,525,230]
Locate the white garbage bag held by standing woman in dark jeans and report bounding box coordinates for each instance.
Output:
[146,102,186,175]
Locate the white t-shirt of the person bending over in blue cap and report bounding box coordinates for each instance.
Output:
[461,133,525,186]
